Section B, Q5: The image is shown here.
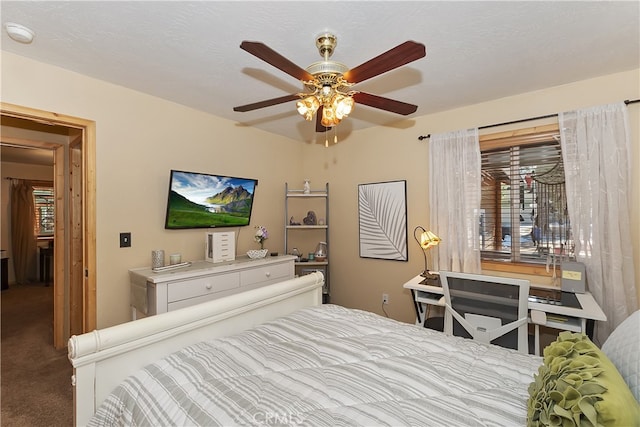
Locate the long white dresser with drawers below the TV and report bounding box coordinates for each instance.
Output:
[129,255,296,320]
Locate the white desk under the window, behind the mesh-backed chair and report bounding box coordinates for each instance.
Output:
[403,275,607,356]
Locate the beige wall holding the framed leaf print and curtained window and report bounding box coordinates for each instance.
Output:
[304,70,640,322]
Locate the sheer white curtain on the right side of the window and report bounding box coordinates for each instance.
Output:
[559,103,638,344]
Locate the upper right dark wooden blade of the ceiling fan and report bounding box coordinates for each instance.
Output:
[343,40,427,83]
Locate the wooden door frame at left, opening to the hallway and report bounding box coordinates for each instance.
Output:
[0,103,96,349]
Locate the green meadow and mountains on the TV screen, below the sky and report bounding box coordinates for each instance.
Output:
[167,181,253,228]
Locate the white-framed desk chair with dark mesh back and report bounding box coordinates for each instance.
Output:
[440,271,529,353]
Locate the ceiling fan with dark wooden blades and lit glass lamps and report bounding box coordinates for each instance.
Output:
[233,33,426,140]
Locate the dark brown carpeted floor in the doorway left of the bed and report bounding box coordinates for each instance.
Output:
[0,284,73,427]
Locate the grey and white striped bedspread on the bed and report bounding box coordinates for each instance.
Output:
[91,305,541,426]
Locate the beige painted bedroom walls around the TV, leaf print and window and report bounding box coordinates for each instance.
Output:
[1,52,640,327]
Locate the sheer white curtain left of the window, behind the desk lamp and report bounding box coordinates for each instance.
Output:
[429,129,481,273]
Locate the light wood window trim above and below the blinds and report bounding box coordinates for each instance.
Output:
[479,123,560,276]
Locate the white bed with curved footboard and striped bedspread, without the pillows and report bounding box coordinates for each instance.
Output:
[70,273,640,426]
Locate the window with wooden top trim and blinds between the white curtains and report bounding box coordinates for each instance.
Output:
[479,125,574,264]
